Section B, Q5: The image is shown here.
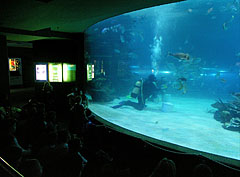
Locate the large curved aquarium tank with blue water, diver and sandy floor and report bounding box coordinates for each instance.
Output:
[85,0,240,166]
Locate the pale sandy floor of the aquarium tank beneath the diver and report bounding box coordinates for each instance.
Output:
[89,97,240,161]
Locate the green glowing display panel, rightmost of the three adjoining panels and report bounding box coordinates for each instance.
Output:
[63,63,76,82]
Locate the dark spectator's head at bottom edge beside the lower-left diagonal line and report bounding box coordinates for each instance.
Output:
[20,159,42,177]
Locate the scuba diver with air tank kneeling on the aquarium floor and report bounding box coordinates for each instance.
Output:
[112,74,159,110]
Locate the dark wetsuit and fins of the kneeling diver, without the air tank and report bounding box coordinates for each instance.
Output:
[112,79,159,110]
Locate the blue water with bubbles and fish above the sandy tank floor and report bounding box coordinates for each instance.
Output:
[85,0,240,99]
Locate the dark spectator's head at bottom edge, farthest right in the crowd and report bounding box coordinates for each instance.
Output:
[193,164,213,177]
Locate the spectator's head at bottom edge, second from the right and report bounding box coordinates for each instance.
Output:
[150,158,176,177]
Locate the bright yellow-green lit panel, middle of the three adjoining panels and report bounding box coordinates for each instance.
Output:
[48,63,62,82]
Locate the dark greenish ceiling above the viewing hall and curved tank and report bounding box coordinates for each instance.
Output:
[0,0,182,42]
